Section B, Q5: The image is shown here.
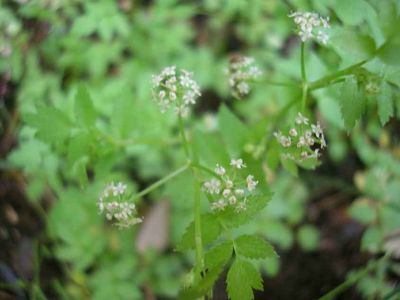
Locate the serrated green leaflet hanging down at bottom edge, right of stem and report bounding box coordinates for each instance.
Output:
[226,258,263,300]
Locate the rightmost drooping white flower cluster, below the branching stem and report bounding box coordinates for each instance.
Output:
[274,113,326,162]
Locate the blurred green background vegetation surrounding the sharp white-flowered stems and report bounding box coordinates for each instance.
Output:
[0,0,400,299]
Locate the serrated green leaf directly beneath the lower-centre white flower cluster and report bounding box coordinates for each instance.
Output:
[216,193,272,228]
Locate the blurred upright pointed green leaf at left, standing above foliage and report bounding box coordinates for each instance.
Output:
[74,84,97,127]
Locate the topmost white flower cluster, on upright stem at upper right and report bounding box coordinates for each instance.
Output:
[289,12,329,45]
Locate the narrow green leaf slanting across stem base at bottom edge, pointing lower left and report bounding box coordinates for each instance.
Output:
[179,264,224,300]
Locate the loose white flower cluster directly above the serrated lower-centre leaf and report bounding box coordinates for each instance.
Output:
[203,158,258,213]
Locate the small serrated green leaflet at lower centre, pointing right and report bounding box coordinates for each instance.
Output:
[235,235,278,259]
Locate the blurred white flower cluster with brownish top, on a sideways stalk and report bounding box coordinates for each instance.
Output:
[225,56,262,97]
